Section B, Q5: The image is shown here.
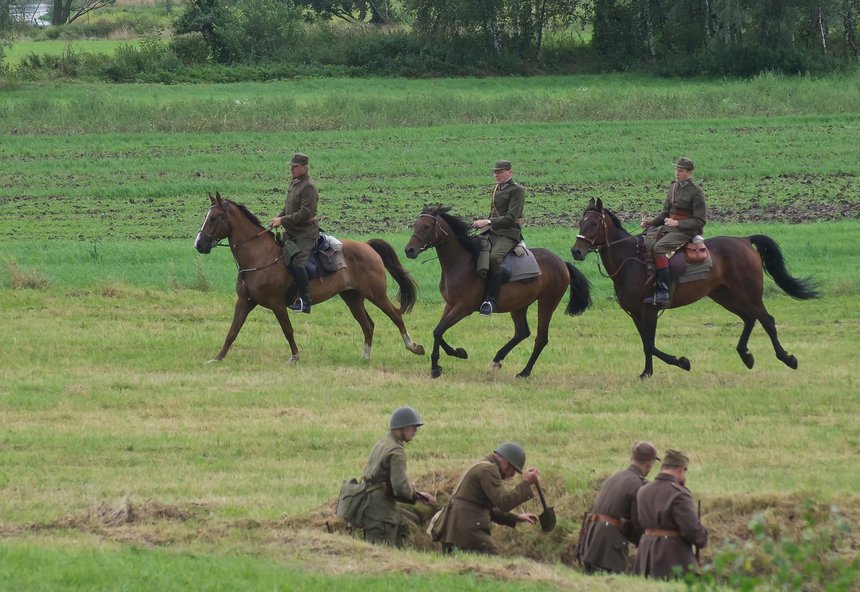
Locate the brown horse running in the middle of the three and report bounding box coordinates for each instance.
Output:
[406,205,591,378]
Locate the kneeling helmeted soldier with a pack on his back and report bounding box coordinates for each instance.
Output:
[360,407,436,547]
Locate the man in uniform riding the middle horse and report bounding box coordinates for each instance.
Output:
[472,160,526,316]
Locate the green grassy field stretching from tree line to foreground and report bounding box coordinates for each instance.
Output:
[0,76,860,590]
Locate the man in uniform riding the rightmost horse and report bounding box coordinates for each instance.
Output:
[642,157,708,306]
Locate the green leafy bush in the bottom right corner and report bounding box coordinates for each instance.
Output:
[684,500,860,592]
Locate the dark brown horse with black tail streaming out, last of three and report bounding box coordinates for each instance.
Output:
[571,199,819,378]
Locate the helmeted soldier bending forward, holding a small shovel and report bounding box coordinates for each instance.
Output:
[440,442,539,555]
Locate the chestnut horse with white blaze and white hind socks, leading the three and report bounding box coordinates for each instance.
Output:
[194,193,424,363]
